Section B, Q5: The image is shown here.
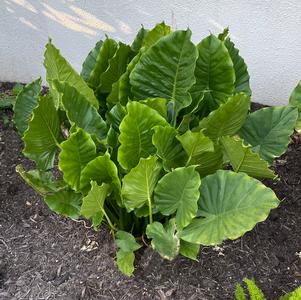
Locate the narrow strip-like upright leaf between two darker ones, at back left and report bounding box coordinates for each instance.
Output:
[88,38,117,90]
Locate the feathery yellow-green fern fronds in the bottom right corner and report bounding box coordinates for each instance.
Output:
[235,278,301,300]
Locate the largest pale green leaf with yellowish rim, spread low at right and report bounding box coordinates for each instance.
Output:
[180,170,279,245]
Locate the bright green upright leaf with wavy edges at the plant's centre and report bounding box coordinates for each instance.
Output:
[118,102,167,169]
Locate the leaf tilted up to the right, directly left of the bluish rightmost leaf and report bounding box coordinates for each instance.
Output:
[194,93,250,141]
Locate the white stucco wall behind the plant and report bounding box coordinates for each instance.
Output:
[0,0,301,104]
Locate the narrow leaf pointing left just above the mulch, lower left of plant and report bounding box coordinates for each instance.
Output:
[16,165,67,196]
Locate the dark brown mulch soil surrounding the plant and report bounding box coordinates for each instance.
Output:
[0,85,301,300]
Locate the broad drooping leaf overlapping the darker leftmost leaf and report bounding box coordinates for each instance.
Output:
[23,96,62,170]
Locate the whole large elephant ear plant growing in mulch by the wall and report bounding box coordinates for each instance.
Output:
[14,23,298,275]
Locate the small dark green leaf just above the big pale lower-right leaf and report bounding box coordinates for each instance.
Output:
[196,145,223,177]
